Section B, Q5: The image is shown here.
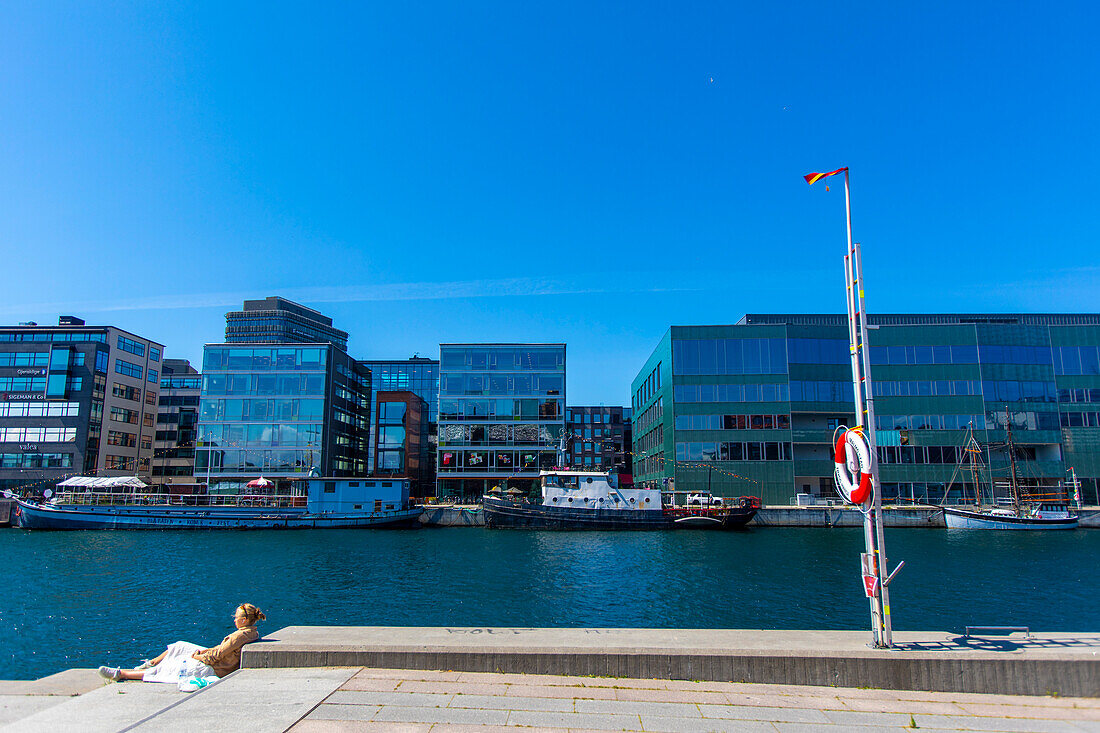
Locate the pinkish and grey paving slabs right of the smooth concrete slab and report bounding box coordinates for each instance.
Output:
[290,669,1100,733]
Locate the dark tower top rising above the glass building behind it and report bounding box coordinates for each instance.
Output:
[226,296,348,351]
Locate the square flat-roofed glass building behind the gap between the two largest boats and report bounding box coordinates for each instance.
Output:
[437,343,565,499]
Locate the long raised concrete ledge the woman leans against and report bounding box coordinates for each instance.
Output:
[242,626,1100,697]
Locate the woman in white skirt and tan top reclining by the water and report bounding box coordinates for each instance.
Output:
[99,603,267,685]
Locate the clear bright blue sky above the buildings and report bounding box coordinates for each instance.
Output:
[0,1,1100,404]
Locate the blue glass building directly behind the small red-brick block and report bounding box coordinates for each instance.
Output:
[359,357,439,488]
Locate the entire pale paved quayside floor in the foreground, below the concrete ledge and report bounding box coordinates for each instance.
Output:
[0,667,1100,733]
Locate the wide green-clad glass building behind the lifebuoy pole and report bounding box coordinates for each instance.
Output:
[631,314,1100,504]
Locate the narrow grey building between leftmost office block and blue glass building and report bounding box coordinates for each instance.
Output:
[153,359,202,492]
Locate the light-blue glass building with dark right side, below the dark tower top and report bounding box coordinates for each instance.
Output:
[195,343,371,490]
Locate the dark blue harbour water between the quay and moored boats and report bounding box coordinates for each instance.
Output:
[0,528,1100,679]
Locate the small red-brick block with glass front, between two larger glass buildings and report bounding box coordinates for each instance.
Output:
[371,390,436,490]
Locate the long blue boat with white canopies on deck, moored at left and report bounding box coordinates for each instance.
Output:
[14,479,420,529]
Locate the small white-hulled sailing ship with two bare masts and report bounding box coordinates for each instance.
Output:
[943,408,1077,529]
